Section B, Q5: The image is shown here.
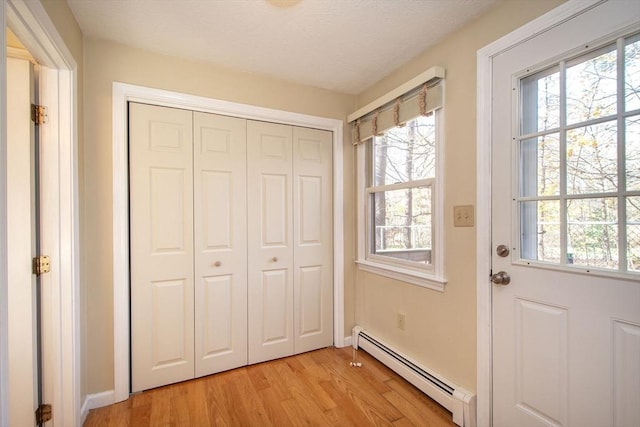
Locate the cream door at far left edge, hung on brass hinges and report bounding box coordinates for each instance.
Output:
[6,58,39,426]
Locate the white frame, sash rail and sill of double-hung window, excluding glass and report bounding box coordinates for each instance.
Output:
[355,108,447,292]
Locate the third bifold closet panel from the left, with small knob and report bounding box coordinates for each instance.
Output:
[247,121,294,363]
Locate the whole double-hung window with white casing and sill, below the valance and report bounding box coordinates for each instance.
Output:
[357,102,446,291]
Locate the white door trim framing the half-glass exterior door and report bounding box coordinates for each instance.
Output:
[476,0,606,427]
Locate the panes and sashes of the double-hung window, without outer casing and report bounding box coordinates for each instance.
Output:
[366,114,436,269]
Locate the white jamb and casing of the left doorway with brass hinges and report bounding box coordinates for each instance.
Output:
[0,0,80,425]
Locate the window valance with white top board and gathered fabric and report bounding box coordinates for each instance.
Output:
[347,67,444,145]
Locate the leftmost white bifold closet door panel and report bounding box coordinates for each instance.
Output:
[129,103,194,392]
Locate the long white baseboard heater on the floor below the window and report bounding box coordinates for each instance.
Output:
[353,326,476,427]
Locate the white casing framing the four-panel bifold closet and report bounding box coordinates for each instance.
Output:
[113,82,351,404]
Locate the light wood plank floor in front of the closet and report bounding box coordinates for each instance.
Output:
[84,347,455,427]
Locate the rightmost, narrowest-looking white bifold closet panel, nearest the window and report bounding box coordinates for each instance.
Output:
[293,127,333,353]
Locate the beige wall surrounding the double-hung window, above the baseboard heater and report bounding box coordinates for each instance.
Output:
[356,0,562,391]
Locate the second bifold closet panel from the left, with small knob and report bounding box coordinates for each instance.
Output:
[194,112,247,377]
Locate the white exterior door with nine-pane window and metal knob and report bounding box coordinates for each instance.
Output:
[492,1,640,427]
